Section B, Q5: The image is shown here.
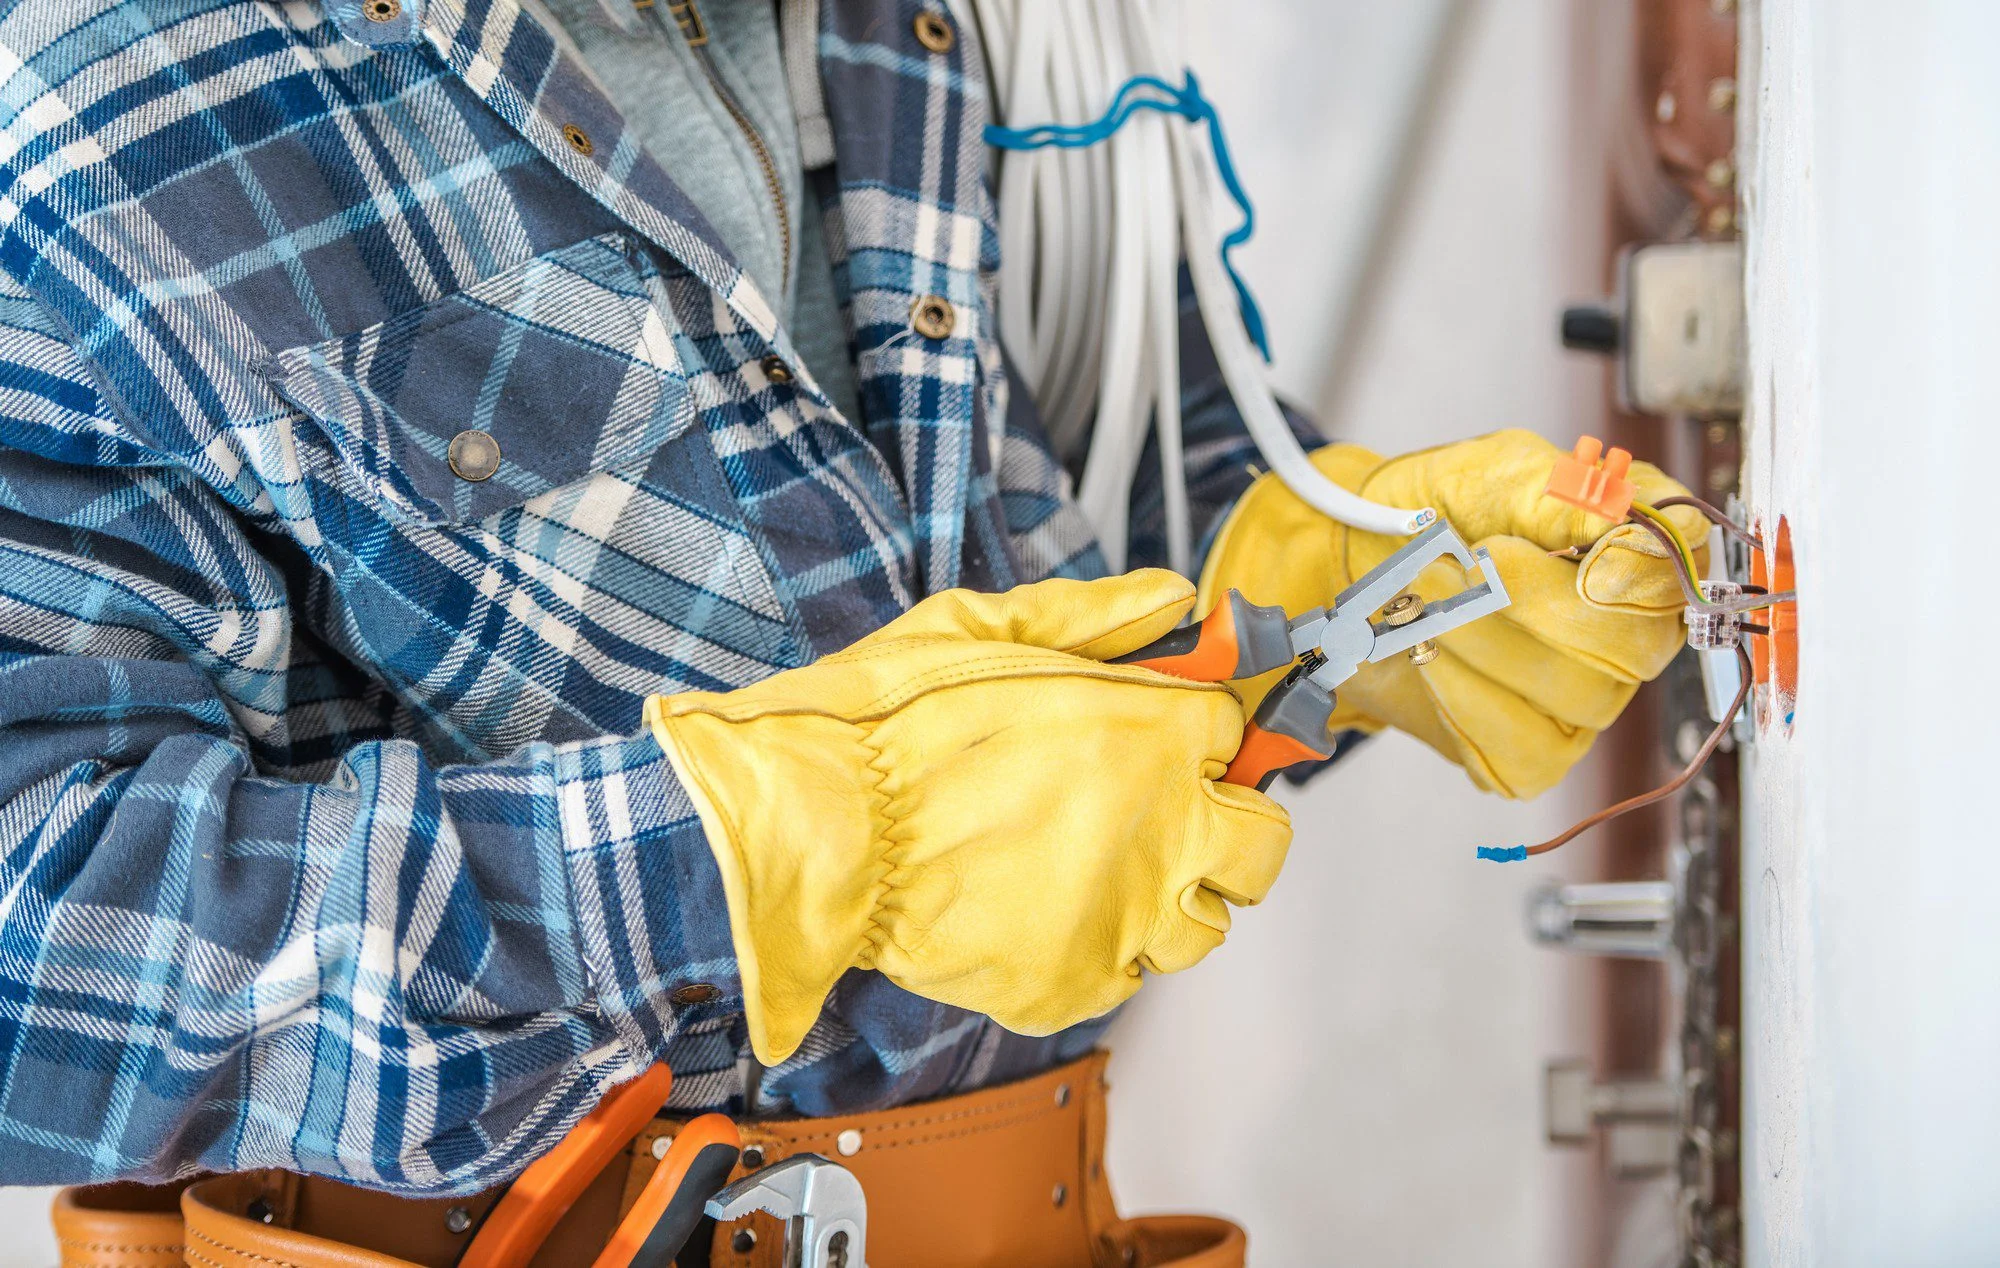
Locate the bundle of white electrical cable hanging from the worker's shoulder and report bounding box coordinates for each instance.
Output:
[950,0,1436,572]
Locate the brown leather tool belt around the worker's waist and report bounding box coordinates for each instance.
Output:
[54,1052,1244,1268]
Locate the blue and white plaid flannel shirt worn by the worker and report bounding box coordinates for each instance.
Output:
[0,0,1280,1192]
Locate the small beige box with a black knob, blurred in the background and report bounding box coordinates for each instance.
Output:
[1562,242,1748,418]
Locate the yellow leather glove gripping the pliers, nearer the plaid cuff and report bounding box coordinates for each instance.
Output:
[646,570,1292,1064]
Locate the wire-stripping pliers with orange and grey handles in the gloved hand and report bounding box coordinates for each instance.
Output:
[1118,520,1514,790]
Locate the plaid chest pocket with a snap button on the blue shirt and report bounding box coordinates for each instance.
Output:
[262,232,694,526]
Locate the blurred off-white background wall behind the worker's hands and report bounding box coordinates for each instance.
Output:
[1110,0,1602,1268]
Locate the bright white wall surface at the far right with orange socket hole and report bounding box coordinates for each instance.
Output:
[1744,0,2000,1266]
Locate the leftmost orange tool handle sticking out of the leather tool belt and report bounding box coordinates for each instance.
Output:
[458,1066,674,1268]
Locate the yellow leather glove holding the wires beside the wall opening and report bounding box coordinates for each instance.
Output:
[1202,430,1708,798]
